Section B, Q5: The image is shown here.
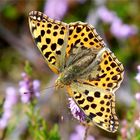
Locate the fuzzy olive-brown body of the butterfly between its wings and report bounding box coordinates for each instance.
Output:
[56,48,95,85]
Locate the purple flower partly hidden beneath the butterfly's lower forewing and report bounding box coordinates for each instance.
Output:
[69,98,86,122]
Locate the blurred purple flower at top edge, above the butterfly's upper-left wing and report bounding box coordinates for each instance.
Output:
[44,0,68,20]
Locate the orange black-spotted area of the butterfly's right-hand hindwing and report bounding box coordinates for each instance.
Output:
[84,48,124,93]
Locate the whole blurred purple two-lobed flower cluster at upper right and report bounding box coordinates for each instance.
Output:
[97,6,137,39]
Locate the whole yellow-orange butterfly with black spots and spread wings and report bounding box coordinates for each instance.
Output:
[29,11,124,132]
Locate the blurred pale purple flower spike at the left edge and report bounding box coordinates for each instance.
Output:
[0,87,18,129]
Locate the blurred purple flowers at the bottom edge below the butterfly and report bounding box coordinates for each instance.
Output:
[70,125,95,140]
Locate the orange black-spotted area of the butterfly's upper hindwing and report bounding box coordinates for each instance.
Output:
[66,22,105,56]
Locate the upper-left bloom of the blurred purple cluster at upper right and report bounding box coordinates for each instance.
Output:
[97,6,116,24]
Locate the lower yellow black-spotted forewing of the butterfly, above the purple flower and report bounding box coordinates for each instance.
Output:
[67,82,119,132]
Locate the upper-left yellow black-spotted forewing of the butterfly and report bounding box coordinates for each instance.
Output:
[29,11,68,73]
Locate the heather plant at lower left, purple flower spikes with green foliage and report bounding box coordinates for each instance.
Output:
[0,63,60,140]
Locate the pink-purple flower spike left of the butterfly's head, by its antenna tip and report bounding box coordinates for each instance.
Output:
[19,73,40,103]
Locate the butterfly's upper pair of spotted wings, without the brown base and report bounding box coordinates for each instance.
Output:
[29,11,105,73]
